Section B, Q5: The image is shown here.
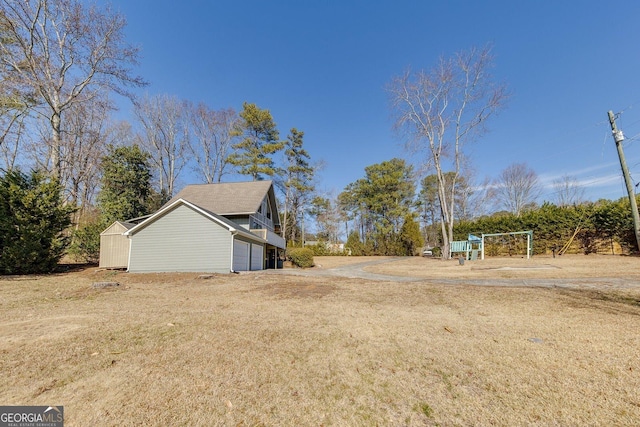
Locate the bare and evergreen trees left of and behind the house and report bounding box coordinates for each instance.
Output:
[0,0,316,270]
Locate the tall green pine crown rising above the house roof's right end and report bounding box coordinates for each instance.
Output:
[229,102,284,181]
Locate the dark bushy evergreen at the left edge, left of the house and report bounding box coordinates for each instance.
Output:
[0,170,75,274]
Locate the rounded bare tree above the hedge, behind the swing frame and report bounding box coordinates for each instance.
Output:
[494,163,541,216]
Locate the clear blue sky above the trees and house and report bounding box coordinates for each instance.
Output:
[111,0,640,201]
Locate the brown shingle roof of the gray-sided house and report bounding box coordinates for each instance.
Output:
[163,181,272,215]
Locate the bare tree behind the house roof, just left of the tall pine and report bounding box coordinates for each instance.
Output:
[186,103,240,184]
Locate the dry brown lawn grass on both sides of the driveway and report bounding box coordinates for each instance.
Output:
[0,257,640,426]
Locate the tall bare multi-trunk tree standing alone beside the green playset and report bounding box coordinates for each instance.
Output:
[389,47,508,258]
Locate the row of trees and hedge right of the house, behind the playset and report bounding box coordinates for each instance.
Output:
[310,158,637,256]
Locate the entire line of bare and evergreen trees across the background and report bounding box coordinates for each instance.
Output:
[0,0,627,274]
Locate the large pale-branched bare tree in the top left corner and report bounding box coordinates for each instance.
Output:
[0,0,144,178]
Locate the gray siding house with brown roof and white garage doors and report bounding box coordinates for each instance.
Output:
[123,181,285,273]
